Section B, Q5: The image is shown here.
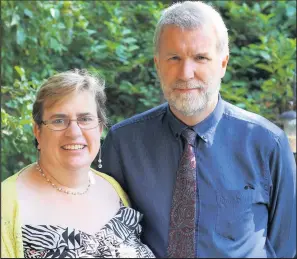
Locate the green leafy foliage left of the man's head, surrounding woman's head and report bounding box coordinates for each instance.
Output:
[1,1,164,179]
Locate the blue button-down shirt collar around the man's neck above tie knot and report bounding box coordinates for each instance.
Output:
[166,94,224,143]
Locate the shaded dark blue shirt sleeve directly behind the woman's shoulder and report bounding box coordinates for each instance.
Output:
[100,129,127,191]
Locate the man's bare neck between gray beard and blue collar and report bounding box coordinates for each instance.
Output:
[170,98,218,126]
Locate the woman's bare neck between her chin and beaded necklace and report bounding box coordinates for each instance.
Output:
[39,158,90,189]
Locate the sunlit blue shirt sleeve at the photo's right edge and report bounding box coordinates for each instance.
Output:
[268,132,296,258]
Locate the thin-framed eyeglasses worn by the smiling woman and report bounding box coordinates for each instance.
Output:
[41,116,100,130]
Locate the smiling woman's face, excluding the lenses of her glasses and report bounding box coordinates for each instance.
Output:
[34,91,102,170]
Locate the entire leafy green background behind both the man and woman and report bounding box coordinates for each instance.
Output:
[1,0,296,180]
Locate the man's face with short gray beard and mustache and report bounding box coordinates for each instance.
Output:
[154,25,228,116]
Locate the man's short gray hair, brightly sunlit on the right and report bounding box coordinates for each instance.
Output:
[154,1,229,55]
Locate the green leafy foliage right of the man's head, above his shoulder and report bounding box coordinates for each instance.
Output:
[217,1,296,121]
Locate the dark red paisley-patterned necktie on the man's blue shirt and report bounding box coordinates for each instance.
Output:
[168,128,197,258]
